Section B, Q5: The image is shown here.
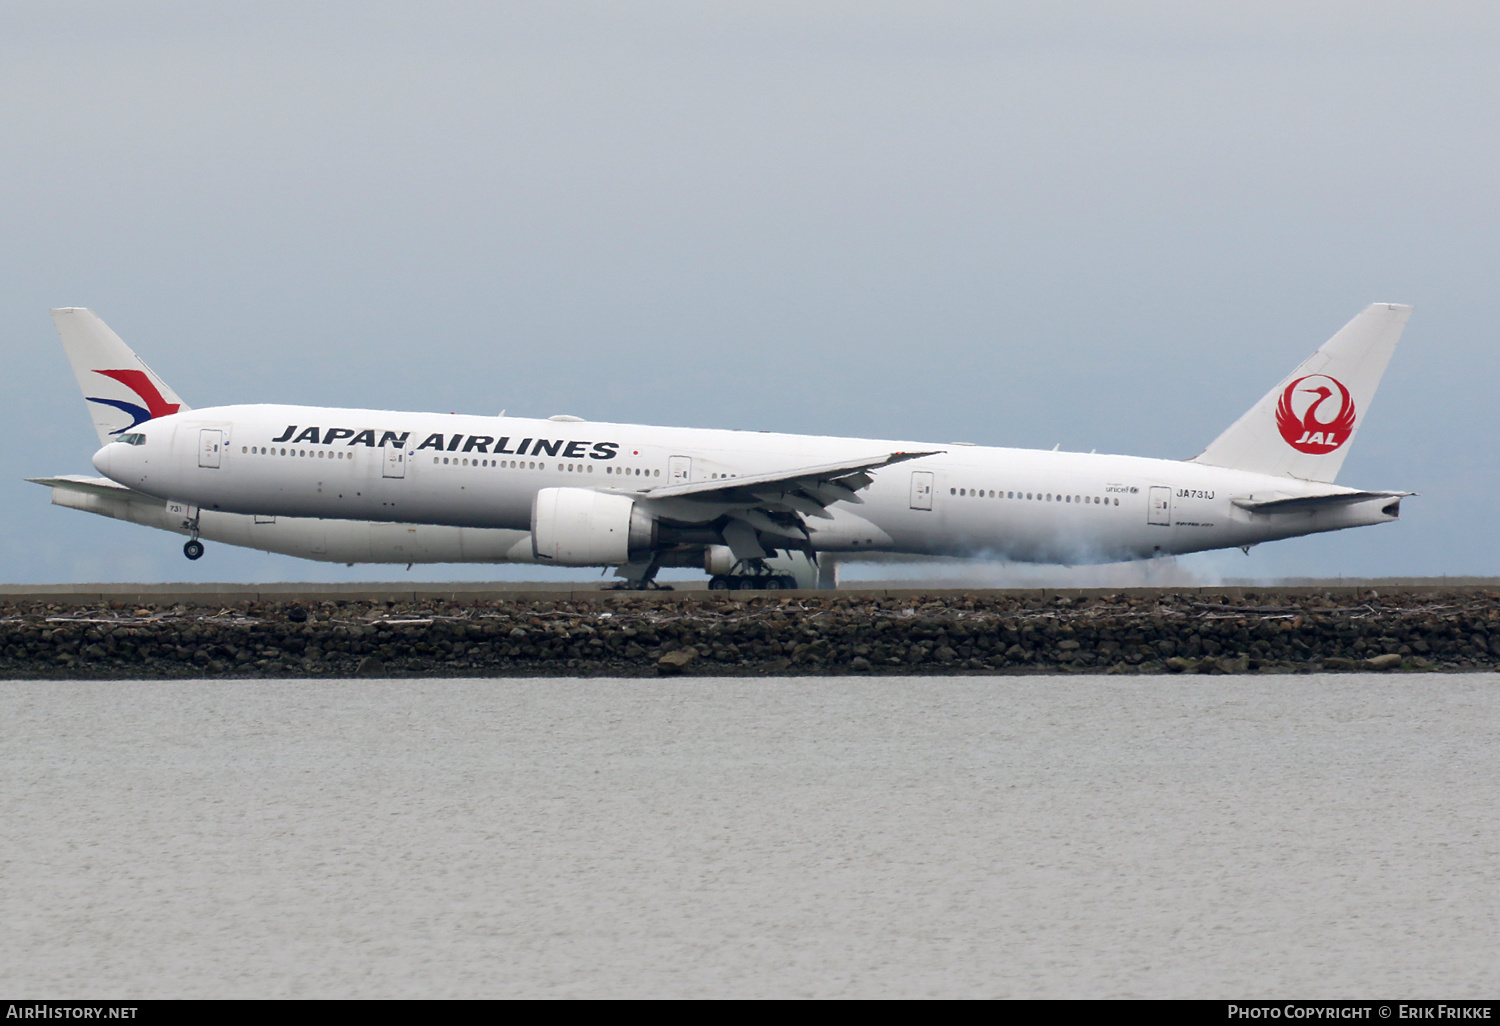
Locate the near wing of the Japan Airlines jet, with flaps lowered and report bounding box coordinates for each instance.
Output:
[627,450,938,560]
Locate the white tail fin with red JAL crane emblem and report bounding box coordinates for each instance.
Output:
[1191,303,1412,482]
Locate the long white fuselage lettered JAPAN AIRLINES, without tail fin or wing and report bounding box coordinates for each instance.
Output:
[95,405,1397,564]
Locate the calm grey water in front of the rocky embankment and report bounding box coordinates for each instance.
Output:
[0,675,1500,998]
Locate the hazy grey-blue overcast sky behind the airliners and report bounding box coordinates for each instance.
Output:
[0,0,1500,582]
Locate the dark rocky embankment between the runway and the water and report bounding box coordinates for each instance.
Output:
[0,591,1500,680]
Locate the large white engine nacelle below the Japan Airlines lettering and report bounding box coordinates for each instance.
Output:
[531,488,656,567]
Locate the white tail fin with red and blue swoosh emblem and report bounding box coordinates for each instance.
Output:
[53,306,189,443]
